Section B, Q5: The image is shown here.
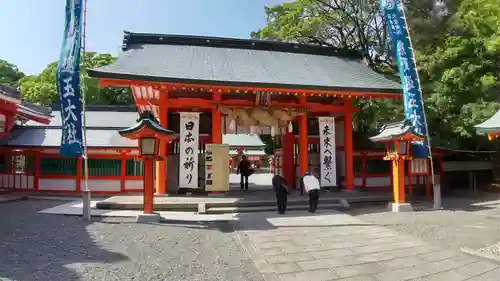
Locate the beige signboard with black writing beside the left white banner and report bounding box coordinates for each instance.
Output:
[205,144,229,192]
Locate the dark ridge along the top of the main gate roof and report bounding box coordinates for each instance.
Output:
[122,31,363,60]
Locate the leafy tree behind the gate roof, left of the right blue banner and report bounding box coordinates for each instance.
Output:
[251,0,402,132]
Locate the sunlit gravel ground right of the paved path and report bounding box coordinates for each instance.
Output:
[347,198,500,250]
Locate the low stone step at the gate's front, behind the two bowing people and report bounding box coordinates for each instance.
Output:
[207,203,346,214]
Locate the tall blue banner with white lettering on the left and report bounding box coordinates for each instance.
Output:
[56,0,83,156]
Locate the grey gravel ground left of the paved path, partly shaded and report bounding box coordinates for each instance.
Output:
[0,200,263,281]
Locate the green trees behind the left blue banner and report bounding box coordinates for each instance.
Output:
[20,52,133,105]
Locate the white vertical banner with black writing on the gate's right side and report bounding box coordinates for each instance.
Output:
[318,117,337,187]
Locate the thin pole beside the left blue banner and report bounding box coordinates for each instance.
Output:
[80,0,92,221]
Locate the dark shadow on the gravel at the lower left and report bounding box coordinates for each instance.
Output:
[0,201,128,281]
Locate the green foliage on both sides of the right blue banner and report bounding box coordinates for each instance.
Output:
[252,0,500,149]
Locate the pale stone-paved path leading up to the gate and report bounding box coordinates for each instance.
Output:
[238,211,500,281]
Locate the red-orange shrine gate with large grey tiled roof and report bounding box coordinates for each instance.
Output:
[88,32,444,194]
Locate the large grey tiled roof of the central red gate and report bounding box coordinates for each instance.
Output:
[88,32,401,93]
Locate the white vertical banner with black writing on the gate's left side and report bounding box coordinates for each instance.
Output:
[179,112,200,188]
